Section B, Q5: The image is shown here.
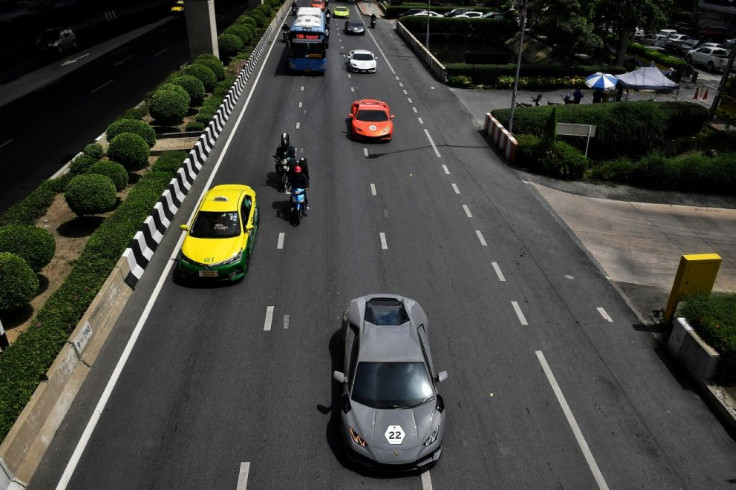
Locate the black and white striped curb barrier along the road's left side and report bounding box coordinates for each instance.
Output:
[123,10,286,288]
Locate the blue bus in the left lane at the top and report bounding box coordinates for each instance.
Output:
[286,7,329,73]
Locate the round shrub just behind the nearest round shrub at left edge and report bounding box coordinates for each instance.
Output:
[0,225,56,272]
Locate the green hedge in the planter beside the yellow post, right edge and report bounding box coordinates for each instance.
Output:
[679,293,736,383]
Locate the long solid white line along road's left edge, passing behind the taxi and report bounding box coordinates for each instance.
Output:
[56,26,276,490]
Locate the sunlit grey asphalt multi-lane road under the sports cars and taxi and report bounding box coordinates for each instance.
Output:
[29,5,736,489]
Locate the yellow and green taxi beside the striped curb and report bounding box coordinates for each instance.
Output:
[177,184,259,281]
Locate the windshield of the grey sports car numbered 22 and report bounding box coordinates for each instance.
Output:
[352,362,434,409]
